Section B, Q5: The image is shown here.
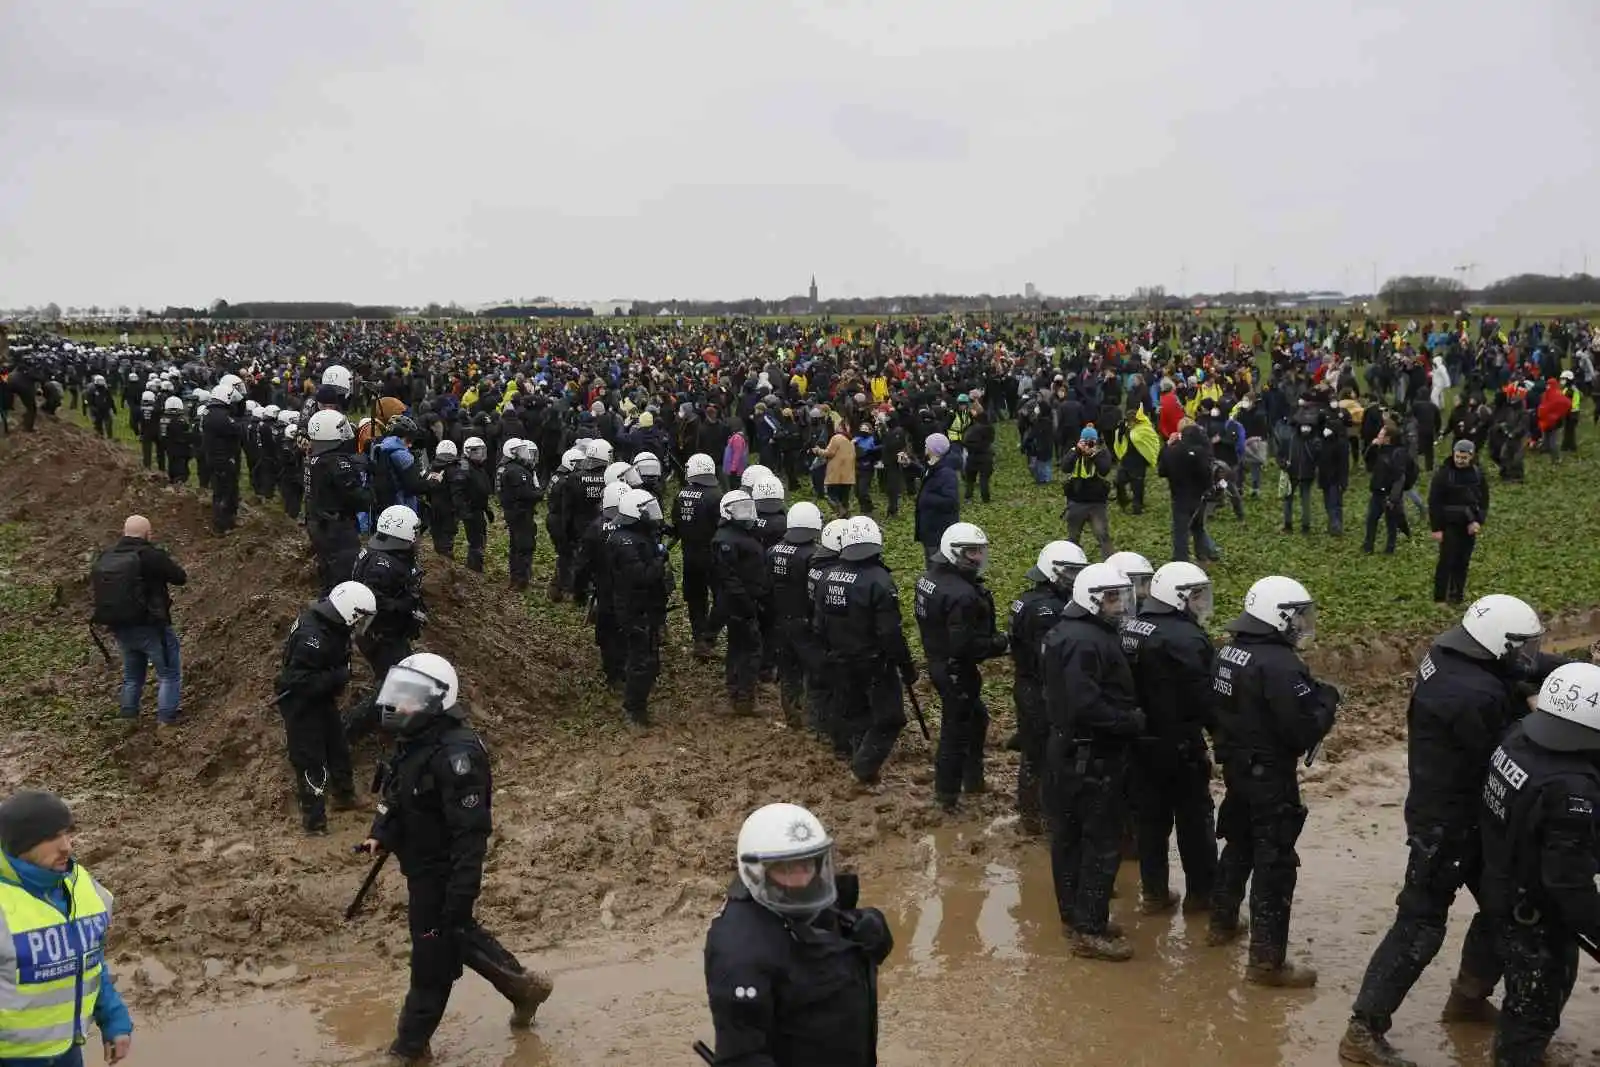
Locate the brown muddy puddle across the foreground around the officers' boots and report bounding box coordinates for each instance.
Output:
[138,749,1600,1067]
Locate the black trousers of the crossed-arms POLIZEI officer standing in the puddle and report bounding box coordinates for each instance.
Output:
[1211,757,1306,966]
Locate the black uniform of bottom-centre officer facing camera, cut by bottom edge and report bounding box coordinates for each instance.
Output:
[706,875,894,1067]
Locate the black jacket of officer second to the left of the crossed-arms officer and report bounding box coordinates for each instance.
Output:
[1040,603,1144,742]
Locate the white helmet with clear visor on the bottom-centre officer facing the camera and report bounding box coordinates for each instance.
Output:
[738,805,838,918]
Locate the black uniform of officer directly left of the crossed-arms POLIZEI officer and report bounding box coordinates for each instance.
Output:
[1122,600,1216,909]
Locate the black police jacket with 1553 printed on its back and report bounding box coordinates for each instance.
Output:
[808,557,912,667]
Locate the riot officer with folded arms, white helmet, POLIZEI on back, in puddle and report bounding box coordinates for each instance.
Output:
[1206,574,1339,989]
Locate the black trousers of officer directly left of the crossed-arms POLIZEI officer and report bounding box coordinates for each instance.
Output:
[1130,729,1218,901]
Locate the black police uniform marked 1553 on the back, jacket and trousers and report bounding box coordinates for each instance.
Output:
[811,555,917,782]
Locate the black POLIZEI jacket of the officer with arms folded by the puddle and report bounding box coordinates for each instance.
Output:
[1211,616,1339,773]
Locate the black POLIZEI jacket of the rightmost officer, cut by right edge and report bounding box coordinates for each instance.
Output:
[1478,723,1600,939]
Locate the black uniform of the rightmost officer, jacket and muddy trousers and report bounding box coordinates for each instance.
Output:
[1480,723,1600,1067]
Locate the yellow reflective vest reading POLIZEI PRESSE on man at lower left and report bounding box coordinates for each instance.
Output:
[0,867,112,1061]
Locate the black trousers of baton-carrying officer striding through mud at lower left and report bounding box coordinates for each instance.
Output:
[394,872,525,1057]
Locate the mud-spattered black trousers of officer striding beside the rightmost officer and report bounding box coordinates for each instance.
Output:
[1350,827,1501,1033]
